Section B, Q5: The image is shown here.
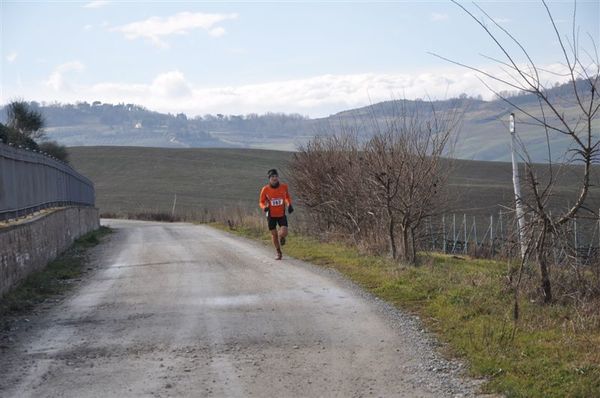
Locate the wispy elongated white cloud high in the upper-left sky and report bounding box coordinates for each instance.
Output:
[110,12,238,48]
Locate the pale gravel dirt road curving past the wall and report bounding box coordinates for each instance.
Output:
[0,220,479,397]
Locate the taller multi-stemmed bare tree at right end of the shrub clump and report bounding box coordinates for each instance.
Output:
[364,101,461,264]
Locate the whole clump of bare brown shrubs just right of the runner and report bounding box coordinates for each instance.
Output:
[290,101,461,263]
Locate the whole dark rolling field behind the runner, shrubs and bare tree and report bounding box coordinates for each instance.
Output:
[69,147,599,220]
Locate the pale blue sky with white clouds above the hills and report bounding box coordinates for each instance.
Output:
[0,0,600,117]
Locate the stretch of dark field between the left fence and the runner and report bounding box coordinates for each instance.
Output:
[69,147,290,214]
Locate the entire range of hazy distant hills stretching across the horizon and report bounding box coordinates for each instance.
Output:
[0,79,600,161]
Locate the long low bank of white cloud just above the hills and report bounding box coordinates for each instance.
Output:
[19,61,567,117]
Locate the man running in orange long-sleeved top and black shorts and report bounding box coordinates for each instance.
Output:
[258,169,294,260]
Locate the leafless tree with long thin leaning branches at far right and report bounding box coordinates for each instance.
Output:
[434,0,600,302]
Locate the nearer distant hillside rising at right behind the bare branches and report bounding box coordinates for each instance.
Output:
[327,82,600,162]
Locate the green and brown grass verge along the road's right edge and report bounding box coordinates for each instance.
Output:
[215,224,600,398]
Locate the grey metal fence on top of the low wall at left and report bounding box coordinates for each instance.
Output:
[0,143,96,221]
